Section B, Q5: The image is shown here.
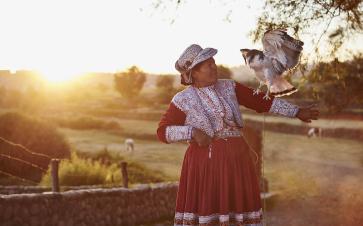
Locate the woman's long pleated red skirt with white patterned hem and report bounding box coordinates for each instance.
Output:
[174,137,262,226]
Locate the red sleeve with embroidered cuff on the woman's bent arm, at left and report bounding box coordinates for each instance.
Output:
[156,103,193,144]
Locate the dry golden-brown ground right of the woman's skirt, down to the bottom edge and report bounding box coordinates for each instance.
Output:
[264,132,363,226]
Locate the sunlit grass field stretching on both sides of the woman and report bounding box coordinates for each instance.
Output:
[57,119,363,226]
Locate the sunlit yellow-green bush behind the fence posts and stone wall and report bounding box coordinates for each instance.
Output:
[41,150,169,186]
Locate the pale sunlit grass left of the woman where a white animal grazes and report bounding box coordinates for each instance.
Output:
[61,129,187,180]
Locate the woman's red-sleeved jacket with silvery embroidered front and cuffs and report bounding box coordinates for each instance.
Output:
[157,79,298,143]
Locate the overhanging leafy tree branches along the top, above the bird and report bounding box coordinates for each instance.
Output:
[154,0,363,56]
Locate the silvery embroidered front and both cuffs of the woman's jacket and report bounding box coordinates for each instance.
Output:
[166,79,299,142]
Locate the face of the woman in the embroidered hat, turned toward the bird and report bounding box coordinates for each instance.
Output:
[192,57,217,85]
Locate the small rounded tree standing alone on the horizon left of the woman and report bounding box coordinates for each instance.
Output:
[114,66,146,102]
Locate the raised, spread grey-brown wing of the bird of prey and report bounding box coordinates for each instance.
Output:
[262,29,304,71]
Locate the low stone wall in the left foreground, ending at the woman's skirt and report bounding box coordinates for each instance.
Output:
[0,183,178,226]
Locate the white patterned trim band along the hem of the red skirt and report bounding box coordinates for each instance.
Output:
[174,208,263,226]
